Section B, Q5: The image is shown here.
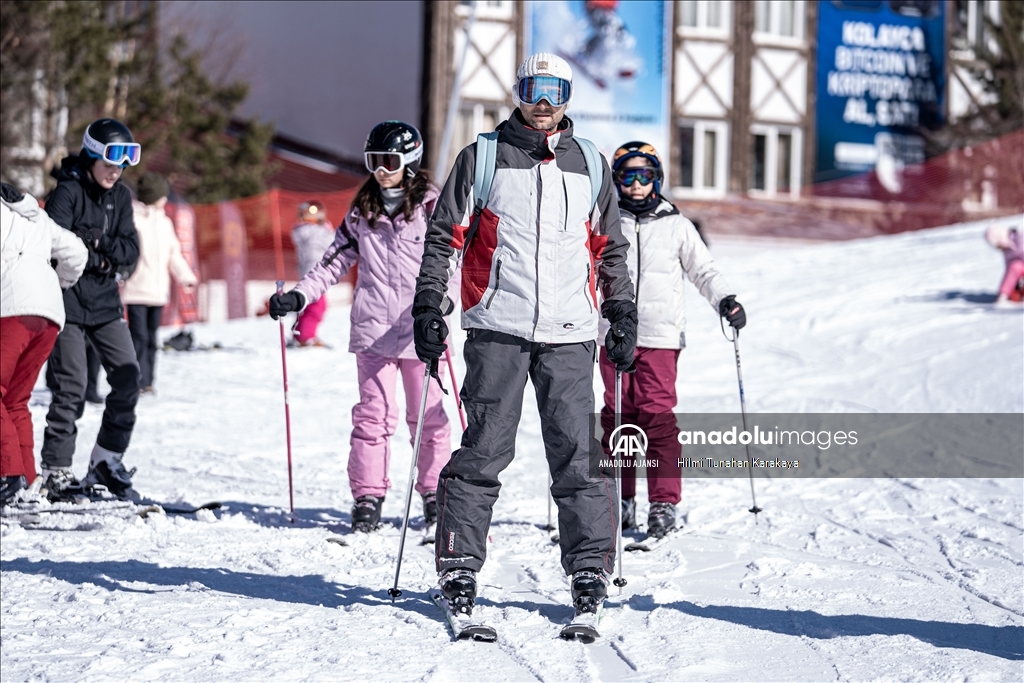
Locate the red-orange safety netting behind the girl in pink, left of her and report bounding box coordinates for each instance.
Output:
[191,187,358,282]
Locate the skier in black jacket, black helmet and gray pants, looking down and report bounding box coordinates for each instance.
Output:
[42,119,141,500]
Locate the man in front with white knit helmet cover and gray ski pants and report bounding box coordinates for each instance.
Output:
[413,53,637,630]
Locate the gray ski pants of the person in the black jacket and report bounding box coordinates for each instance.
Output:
[42,318,138,468]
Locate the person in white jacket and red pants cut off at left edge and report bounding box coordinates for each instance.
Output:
[0,183,89,505]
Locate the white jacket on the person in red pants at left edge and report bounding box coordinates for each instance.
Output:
[0,195,89,330]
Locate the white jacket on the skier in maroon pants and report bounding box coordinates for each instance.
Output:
[599,199,735,348]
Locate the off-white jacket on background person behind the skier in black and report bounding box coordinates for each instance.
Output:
[121,202,199,306]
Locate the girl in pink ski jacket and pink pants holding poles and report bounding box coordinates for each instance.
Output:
[270,121,459,531]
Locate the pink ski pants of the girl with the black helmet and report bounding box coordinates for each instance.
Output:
[348,352,452,498]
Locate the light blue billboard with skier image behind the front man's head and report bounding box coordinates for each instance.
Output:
[525,0,672,181]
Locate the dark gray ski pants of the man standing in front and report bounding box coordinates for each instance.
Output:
[435,330,618,574]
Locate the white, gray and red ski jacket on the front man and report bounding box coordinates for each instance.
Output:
[417,115,632,343]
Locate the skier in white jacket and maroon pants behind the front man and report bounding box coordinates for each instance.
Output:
[600,141,746,538]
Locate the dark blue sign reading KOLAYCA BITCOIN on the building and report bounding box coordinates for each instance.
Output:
[814,0,945,193]
